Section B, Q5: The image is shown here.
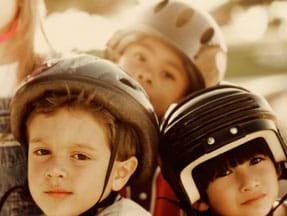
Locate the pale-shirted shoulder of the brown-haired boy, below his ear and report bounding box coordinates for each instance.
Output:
[98,197,151,216]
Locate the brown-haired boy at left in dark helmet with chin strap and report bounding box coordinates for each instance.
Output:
[11,56,161,215]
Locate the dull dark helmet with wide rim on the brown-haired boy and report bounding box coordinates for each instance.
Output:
[11,55,159,184]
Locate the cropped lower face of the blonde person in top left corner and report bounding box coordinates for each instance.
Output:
[0,0,18,34]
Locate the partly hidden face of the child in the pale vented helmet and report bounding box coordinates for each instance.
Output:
[118,37,189,118]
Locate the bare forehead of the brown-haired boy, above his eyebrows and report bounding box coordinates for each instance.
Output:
[27,107,111,144]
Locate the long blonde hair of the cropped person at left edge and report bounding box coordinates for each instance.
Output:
[0,0,42,82]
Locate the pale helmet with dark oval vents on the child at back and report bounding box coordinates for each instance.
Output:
[106,0,227,87]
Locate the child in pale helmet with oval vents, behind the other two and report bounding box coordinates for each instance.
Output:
[106,0,227,216]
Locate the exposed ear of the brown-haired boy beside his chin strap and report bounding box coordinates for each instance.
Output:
[112,156,138,191]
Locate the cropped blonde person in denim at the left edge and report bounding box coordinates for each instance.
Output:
[0,0,45,215]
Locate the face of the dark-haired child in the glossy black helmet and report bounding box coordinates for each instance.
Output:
[207,155,278,216]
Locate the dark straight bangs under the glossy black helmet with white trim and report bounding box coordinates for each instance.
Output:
[192,137,276,201]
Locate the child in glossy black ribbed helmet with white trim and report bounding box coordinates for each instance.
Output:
[159,84,287,216]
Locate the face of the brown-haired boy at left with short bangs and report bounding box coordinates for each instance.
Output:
[27,108,118,215]
